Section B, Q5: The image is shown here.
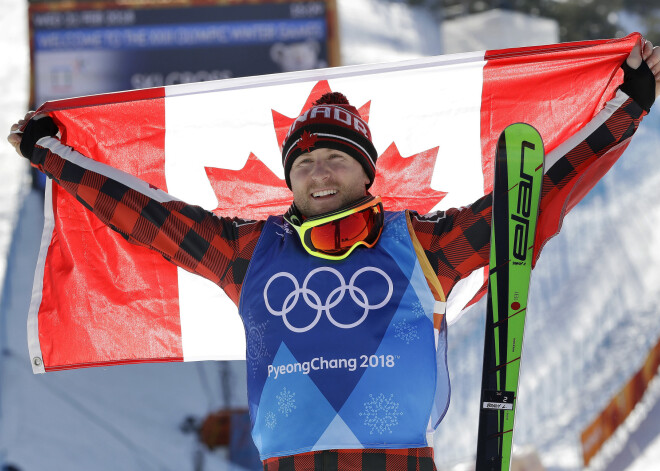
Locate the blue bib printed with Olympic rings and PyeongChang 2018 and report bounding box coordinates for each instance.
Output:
[239,212,449,459]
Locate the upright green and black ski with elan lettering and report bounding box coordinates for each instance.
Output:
[476,123,544,471]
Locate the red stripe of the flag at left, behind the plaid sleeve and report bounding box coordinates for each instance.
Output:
[39,88,183,370]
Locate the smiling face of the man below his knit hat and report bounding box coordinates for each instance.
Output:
[289,148,369,217]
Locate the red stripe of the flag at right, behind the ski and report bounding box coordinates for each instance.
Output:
[481,33,640,258]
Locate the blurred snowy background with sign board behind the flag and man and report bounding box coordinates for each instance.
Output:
[0,0,660,471]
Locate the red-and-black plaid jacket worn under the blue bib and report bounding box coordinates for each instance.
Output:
[35,92,645,470]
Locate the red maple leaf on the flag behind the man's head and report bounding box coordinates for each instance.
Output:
[206,80,446,219]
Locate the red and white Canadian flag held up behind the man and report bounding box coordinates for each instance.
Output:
[28,34,639,373]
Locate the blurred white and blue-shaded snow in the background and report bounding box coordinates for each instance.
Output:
[0,0,660,471]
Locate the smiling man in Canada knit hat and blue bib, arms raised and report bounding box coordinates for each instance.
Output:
[9,42,660,471]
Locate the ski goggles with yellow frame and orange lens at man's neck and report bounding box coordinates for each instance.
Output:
[287,196,384,260]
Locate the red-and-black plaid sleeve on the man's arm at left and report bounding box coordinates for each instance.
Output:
[34,138,264,304]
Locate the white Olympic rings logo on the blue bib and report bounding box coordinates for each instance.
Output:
[264,267,394,333]
